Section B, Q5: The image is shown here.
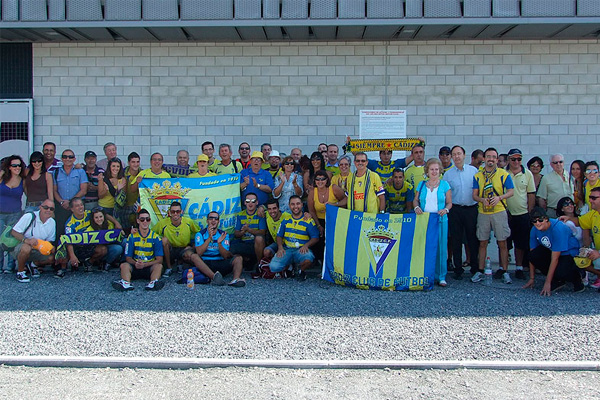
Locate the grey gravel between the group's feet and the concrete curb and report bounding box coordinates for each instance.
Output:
[0,271,600,362]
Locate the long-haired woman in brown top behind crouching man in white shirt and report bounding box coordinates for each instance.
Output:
[23,151,54,212]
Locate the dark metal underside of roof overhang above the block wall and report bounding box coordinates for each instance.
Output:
[0,17,600,42]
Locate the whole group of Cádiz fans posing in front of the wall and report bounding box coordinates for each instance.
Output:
[0,142,600,294]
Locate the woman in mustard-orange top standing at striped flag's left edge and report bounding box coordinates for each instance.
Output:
[308,170,348,261]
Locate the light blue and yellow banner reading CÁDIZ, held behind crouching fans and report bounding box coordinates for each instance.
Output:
[139,174,241,233]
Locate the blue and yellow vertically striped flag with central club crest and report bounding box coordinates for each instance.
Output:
[322,205,439,290]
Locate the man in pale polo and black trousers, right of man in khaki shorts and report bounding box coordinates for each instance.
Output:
[506,149,535,279]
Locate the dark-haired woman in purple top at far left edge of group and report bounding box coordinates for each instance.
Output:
[0,155,25,274]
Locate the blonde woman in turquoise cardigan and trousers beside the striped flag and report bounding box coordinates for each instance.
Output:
[413,158,452,287]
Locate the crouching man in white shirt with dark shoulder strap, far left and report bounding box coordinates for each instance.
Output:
[10,199,56,283]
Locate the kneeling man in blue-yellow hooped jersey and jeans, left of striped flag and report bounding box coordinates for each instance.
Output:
[270,195,319,281]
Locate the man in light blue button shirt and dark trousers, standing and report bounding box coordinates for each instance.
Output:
[443,146,479,279]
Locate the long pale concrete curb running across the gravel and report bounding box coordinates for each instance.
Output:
[0,356,600,371]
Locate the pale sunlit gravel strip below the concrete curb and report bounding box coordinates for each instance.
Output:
[0,367,600,400]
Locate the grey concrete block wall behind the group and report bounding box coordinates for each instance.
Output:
[33,40,600,170]
